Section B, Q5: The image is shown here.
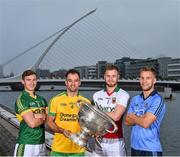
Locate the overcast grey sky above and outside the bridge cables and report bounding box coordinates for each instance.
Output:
[0,0,180,67]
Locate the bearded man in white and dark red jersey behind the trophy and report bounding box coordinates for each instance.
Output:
[93,64,129,157]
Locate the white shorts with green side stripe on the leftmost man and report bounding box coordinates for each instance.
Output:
[14,144,47,157]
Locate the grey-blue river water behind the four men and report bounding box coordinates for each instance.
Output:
[0,91,180,156]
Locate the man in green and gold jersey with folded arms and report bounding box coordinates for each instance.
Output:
[14,70,47,156]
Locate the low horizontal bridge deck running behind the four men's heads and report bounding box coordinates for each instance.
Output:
[0,78,180,90]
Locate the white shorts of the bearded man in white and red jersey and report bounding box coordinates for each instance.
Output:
[92,138,126,157]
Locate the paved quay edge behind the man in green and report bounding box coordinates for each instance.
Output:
[0,104,53,156]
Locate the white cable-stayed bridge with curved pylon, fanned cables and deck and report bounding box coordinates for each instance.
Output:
[0,9,180,89]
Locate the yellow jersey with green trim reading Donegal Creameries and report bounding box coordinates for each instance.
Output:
[48,92,90,153]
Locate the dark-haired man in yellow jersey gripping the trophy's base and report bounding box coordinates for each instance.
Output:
[47,69,90,156]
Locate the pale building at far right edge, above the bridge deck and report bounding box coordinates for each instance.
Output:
[168,58,180,80]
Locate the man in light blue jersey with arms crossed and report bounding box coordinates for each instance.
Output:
[125,67,166,156]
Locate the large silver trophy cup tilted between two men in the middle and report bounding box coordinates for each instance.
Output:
[65,101,118,150]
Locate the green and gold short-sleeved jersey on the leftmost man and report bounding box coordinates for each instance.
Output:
[15,91,47,144]
